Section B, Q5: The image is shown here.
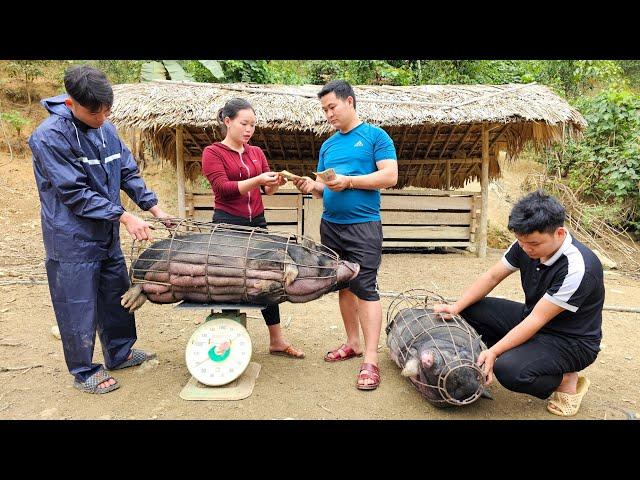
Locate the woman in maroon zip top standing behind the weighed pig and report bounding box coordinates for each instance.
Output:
[202,98,304,358]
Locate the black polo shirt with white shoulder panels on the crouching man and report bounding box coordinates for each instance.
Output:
[502,232,604,346]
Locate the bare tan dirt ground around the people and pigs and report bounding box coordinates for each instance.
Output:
[0,154,640,420]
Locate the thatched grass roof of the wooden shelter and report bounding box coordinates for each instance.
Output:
[111,81,586,188]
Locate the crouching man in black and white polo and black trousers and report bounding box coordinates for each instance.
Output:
[433,190,604,416]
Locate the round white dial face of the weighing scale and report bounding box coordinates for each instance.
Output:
[185,318,251,386]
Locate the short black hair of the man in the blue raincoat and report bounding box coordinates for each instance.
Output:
[64,65,113,112]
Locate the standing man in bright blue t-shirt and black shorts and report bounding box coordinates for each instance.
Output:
[294,80,398,390]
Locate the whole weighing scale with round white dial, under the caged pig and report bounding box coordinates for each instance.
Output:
[175,301,266,400]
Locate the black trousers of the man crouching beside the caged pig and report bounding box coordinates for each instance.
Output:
[460,297,598,399]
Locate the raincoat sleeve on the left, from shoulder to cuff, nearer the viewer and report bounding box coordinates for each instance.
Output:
[39,131,124,221]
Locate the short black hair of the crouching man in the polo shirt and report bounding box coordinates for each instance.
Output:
[508,189,567,235]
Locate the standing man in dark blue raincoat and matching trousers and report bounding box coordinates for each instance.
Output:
[29,65,168,393]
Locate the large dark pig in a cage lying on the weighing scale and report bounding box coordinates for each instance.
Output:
[122,219,360,312]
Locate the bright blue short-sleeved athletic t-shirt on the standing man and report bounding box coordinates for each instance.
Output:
[318,123,397,224]
